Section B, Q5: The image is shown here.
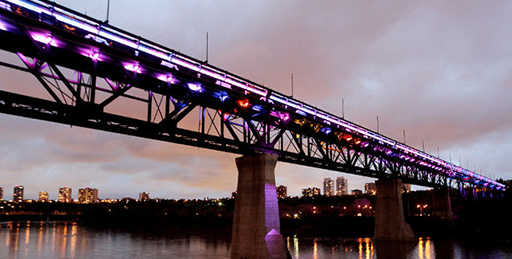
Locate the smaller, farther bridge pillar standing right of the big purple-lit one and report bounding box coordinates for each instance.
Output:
[375,179,418,241]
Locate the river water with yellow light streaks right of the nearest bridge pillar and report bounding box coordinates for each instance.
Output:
[288,235,512,259]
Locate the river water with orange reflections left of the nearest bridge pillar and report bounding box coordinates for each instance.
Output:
[0,222,230,259]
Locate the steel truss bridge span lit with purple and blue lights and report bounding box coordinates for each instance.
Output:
[0,0,506,191]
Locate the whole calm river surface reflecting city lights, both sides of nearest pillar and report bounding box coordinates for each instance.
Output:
[0,222,512,259]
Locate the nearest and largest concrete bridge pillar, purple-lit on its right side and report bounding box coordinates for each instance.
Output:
[231,154,291,259]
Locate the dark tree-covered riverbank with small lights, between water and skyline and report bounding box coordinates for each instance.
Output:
[0,191,512,240]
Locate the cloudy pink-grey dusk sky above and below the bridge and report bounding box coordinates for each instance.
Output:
[0,0,512,199]
